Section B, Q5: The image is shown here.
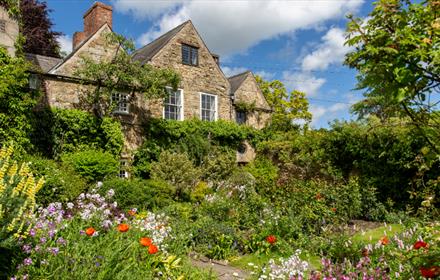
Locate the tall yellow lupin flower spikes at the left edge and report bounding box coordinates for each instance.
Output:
[0,147,44,241]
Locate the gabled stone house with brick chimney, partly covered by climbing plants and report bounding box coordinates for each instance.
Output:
[0,2,271,165]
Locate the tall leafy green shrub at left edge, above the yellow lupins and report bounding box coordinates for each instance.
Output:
[0,47,38,149]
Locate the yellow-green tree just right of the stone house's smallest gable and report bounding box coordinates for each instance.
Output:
[256,76,312,130]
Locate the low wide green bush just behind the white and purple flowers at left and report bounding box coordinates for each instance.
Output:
[99,178,175,210]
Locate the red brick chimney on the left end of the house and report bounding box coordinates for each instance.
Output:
[73,2,113,50]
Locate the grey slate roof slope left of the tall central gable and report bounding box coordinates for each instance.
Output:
[133,20,190,64]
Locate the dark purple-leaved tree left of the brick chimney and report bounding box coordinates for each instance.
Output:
[20,0,62,57]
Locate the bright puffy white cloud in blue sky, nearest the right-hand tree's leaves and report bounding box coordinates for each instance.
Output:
[301,28,351,71]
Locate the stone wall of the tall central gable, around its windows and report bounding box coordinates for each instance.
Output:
[150,22,233,120]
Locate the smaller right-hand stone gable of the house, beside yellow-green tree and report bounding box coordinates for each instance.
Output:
[234,73,271,129]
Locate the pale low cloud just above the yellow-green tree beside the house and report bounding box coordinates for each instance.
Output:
[282,71,326,97]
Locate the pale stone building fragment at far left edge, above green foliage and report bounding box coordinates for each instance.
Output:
[0,7,19,56]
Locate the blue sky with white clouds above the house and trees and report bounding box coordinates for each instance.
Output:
[47,0,373,128]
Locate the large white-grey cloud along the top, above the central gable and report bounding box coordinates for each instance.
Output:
[113,0,363,55]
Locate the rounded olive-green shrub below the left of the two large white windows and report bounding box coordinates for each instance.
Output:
[151,151,201,198]
